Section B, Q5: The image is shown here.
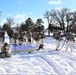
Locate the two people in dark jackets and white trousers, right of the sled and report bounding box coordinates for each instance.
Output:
[53,32,75,52]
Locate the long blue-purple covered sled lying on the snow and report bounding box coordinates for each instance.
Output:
[10,44,36,53]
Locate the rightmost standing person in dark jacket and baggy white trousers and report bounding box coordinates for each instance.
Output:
[66,33,75,52]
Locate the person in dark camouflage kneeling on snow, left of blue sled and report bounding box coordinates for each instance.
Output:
[0,43,11,58]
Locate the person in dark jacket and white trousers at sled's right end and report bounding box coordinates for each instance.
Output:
[32,26,45,50]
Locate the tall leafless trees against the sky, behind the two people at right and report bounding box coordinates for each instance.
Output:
[44,8,76,34]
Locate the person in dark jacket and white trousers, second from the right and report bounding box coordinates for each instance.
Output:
[53,32,62,50]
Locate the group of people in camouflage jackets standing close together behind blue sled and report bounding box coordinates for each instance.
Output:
[11,26,44,50]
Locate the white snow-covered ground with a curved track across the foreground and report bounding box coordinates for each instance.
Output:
[0,37,76,75]
